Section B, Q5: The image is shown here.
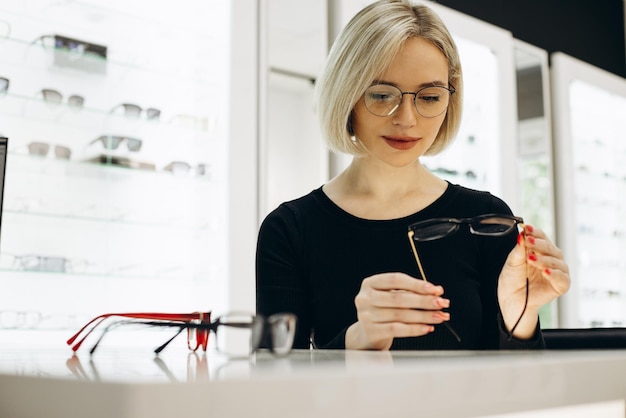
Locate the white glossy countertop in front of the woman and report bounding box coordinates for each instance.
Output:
[0,347,626,418]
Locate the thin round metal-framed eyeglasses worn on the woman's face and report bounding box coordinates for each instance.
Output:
[363,84,456,118]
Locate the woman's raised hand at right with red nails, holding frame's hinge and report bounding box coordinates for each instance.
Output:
[498,225,570,339]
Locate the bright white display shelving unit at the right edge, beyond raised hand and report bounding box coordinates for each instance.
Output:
[551,53,626,327]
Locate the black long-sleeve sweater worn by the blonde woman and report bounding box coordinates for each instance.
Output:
[256,184,544,350]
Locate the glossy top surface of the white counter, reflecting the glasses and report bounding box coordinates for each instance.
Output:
[0,340,626,383]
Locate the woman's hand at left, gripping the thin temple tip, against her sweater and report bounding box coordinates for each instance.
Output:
[345,273,450,350]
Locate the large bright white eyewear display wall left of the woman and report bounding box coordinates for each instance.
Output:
[0,0,230,336]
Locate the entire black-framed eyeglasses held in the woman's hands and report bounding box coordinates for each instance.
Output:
[408,213,528,342]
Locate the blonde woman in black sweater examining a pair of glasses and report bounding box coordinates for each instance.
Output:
[257,0,570,350]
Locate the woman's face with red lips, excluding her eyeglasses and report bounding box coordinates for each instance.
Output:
[352,38,448,167]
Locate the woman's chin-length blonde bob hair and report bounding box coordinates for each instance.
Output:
[315,0,463,155]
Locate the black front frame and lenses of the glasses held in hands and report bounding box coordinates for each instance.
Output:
[409,214,524,241]
